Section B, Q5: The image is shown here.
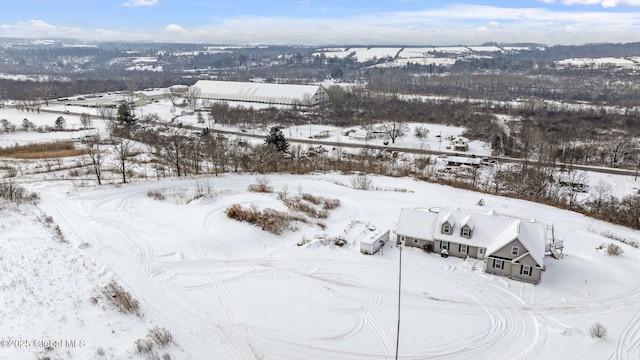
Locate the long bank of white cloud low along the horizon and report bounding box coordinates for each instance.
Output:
[0,0,640,45]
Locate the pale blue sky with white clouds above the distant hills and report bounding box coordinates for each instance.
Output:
[0,0,640,45]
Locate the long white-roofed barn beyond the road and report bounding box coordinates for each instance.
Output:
[193,80,329,106]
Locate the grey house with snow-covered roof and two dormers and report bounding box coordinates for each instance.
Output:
[396,209,547,284]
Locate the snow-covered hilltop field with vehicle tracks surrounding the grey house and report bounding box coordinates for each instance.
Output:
[0,170,640,359]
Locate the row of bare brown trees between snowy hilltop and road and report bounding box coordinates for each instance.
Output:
[84,119,640,228]
